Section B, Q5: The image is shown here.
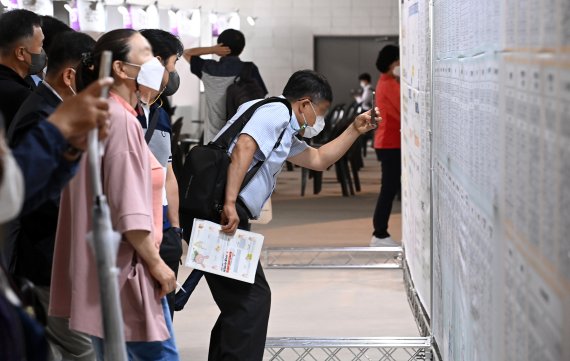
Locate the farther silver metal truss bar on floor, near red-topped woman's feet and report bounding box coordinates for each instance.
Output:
[261,247,403,269]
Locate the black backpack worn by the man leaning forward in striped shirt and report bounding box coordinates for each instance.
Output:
[179,97,291,240]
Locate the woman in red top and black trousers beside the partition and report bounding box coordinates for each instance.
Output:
[370,45,401,247]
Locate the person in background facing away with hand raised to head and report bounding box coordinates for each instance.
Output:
[183,29,267,144]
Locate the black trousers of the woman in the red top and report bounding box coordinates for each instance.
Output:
[373,149,402,238]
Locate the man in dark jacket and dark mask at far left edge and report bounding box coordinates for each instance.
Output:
[0,10,46,128]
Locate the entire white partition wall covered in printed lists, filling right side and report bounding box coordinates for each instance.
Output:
[401,0,570,361]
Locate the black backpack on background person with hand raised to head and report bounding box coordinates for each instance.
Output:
[226,62,265,120]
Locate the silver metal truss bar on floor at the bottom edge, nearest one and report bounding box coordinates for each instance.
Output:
[263,337,432,361]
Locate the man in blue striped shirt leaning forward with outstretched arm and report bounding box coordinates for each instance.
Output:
[205,70,377,361]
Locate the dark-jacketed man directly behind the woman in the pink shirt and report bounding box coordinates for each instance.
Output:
[8,32,95,360]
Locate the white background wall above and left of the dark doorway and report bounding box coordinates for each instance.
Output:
[164,0,399,133]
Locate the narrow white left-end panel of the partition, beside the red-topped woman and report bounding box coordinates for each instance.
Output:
[400,1,431,316]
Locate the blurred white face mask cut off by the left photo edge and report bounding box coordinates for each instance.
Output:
[0,152,24,223]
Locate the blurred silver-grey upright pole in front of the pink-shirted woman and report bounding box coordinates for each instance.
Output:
[88,51,127,361]
